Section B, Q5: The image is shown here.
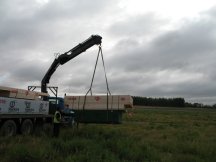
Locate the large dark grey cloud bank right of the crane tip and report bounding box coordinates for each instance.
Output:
[109,13,216,70]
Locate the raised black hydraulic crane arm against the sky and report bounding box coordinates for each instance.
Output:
[41,35,102,97]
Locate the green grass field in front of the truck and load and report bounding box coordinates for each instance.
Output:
[0,108,216,162]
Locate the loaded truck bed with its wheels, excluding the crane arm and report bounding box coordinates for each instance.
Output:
[0,86,52,136]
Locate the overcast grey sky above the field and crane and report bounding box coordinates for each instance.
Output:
[0,0,216,104]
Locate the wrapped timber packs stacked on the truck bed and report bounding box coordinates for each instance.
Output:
[0,86,49,115]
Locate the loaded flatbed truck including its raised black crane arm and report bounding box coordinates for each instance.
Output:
[0,35,102,136]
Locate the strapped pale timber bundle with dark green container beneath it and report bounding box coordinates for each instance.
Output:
[65,95,133,123]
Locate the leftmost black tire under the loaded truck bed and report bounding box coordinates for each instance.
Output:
[0,120,17,137]
